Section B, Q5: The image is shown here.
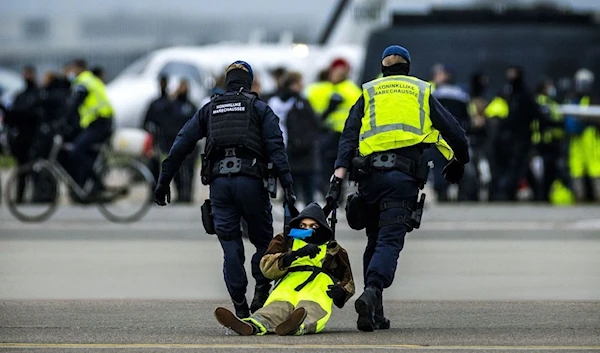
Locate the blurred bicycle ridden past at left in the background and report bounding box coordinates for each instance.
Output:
[5,135,155,222]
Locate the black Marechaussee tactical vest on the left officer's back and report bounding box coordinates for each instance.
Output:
[206,92,264,161]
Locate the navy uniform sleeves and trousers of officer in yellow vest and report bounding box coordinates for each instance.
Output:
[335,92,469,290]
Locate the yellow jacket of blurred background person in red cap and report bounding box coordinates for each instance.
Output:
[307,80,361,132]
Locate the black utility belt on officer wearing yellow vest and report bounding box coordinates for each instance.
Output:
[350,152,431,189]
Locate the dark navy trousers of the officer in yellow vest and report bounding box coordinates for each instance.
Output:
[359,170,419,290]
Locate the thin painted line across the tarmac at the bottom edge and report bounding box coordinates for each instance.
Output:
[0,343,600,351]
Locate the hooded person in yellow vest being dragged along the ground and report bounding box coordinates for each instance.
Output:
[215,203,354,336]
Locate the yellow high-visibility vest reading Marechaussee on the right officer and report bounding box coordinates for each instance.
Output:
[358,75,454,160]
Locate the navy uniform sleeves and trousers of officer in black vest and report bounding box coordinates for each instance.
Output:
[159,87,292,304]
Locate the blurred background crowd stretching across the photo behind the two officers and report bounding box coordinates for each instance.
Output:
[2,58,600,204]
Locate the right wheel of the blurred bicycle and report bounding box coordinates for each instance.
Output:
[98,160,154,222]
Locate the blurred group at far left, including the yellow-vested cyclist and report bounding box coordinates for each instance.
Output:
[0,59,113,202]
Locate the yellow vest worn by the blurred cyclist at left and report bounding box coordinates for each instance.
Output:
[73,71,113,129]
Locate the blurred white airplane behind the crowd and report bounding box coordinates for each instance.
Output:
[107,43,364,127]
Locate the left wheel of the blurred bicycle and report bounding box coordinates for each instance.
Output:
[4,161,59,222]
